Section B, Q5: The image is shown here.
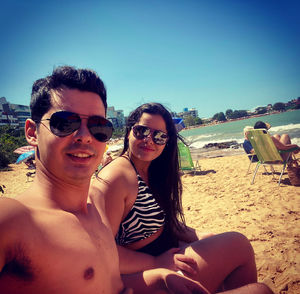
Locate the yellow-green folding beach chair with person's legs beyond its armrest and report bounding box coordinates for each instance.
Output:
[248,129,297,186]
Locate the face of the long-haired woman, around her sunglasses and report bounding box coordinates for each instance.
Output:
[128,112,167,162]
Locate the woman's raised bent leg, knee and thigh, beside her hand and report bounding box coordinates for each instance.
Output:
[182,232,257,292]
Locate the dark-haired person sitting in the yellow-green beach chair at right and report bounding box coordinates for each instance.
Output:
[254,121,300,160]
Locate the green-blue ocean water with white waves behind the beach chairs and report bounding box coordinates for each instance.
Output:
[180,109,300,148]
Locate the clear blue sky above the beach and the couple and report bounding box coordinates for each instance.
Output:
[0,0,300,118]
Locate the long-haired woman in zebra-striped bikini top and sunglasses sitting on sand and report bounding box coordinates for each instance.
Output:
[90,103,271,294]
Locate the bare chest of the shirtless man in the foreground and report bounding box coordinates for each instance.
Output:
[1,210,118,293]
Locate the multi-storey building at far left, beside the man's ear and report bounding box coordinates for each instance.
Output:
[0,97,30,129]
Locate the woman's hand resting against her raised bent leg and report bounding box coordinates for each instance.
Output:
[154,248,197,276]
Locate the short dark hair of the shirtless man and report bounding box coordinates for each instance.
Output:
[30,66,107,122]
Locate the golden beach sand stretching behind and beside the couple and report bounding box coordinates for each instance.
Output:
[0,151,300,294]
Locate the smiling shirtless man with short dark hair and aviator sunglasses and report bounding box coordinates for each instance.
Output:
[0,67,208,294]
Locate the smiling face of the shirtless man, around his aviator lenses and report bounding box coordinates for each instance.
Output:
[37,89,106,184]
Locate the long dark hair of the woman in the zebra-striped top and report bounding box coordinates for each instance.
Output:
[122,103,185,231]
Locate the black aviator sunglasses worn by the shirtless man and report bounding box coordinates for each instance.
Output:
[41,111,114,142]
